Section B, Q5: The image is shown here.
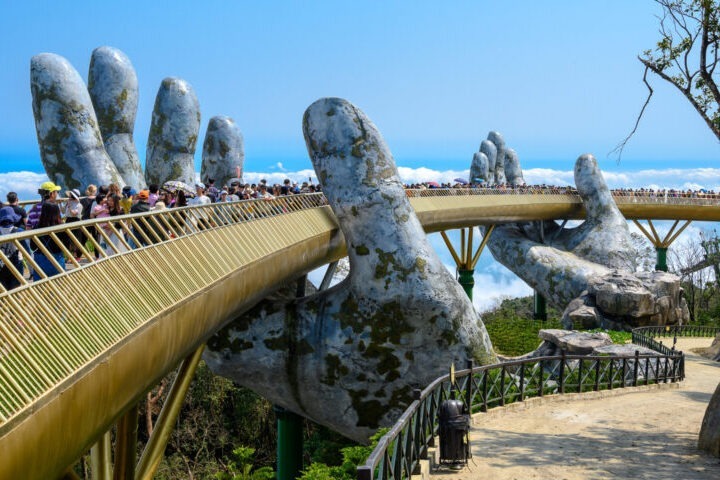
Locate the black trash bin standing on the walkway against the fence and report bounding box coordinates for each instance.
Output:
[438,400,470,465]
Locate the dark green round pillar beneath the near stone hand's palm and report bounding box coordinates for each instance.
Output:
[275,406,304,480]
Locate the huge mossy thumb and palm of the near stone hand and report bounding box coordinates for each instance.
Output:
[204,98,496,441]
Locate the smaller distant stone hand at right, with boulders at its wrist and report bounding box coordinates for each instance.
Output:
[476,134,689,329]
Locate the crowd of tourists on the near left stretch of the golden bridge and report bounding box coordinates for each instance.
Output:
[0,178,320,290]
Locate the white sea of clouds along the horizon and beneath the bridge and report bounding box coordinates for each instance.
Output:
[7,167,720,312]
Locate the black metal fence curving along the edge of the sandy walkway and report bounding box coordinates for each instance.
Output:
[357,326,720,480]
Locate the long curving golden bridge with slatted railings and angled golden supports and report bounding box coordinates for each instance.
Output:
[0,189,720,479]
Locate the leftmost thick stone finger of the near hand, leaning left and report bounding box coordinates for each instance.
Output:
[30,53,124,191]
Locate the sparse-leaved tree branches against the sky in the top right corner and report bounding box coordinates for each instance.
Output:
[611,0,720,157]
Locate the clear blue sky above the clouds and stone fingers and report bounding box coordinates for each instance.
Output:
[0,0,719,172]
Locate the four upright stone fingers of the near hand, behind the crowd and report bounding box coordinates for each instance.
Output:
[30,47,244,190]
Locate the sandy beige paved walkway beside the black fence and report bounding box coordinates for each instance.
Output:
[431,339,720,480]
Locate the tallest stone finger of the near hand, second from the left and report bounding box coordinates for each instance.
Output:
[88,47,146,189]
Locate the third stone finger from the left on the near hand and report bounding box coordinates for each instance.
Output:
[145,78,200,185]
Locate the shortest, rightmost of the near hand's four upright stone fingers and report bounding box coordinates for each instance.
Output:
[200,116,245,186]
